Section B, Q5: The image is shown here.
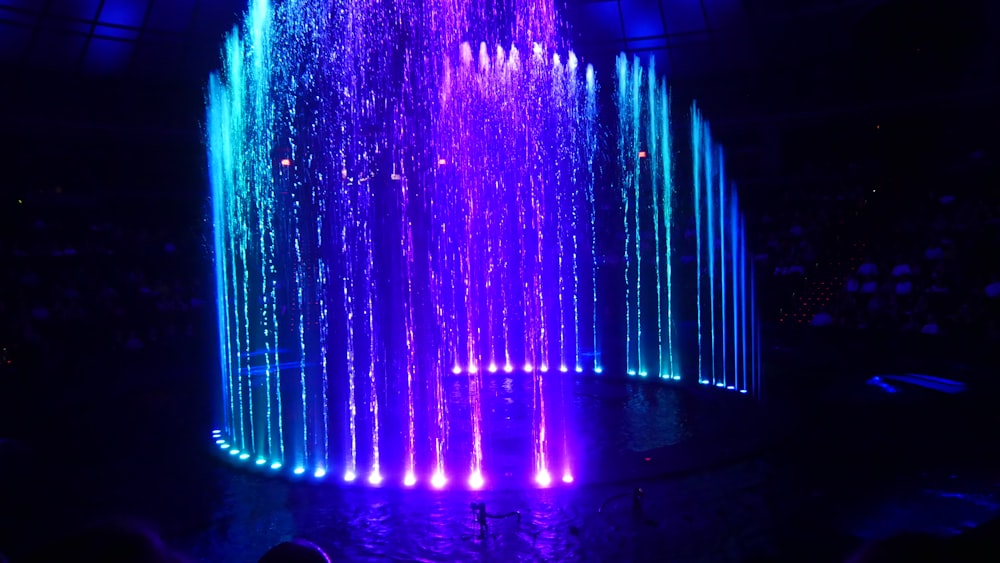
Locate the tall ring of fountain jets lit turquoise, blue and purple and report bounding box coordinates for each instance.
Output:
[206,0,758,489]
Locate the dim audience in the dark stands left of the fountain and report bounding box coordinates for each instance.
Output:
[0,192,208,367]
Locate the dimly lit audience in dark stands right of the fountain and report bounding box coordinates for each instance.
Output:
[754,159,1000,342]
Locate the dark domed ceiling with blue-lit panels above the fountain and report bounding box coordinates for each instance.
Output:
[0,0,1000,107]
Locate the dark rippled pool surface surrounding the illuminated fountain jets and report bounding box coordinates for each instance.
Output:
[0,338,1000,562]
